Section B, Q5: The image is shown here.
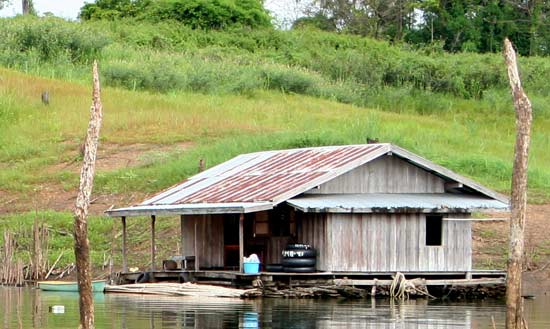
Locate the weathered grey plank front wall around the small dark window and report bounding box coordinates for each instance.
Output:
[298,214,472,272]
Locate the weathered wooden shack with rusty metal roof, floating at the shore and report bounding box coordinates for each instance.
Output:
[107,144,508,273]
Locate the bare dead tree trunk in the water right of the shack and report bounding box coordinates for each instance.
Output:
[504,39,533,329]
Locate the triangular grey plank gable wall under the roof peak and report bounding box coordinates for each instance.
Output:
[306,155,445,194]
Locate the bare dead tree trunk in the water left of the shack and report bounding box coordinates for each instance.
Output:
[74,61,102,329]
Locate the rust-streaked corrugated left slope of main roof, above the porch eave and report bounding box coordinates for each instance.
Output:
[141,144,390,205]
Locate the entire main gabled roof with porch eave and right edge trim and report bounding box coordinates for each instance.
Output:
[106,144,508,216]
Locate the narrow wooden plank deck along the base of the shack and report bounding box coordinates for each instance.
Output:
[119,270,506,288]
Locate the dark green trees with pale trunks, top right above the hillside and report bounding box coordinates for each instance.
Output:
[302,0,550,55]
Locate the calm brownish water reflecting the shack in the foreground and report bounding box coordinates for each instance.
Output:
[0,287,550,329]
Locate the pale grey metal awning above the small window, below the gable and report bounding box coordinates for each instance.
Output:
[287,193,508,213]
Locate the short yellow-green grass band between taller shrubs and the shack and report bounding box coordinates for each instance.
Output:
[0,69,550,201]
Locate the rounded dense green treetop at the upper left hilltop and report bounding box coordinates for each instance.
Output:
[80,0,271,29]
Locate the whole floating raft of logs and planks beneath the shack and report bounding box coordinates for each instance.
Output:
[114,271,506,298]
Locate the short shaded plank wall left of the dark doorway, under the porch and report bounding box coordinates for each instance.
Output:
[183,215,224,268]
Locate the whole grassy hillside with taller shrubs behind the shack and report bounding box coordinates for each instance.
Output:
[0,18,550,270]
